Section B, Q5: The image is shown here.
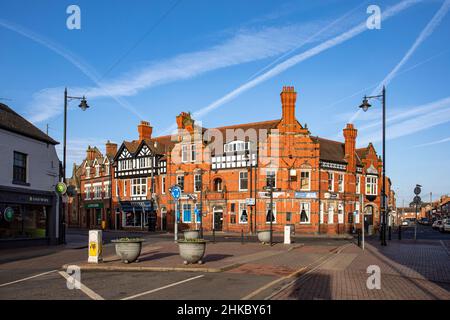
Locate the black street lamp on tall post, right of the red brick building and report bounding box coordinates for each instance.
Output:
[359,86,387,246]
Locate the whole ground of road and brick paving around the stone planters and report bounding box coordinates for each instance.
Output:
[0,228,450,300]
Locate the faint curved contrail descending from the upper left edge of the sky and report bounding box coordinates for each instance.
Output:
[0,19,143,119]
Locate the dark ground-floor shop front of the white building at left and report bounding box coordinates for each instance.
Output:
[0,187,58,247]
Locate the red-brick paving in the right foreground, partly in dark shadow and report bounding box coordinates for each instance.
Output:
[272,240,450,300]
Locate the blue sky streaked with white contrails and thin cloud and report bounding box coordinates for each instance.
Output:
[0,0,450,205]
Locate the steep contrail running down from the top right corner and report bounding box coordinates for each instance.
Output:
[349,0,450,123]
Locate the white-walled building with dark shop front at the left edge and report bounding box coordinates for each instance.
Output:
[0,103,62,247]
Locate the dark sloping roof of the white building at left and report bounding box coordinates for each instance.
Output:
[0,103,59,145]
